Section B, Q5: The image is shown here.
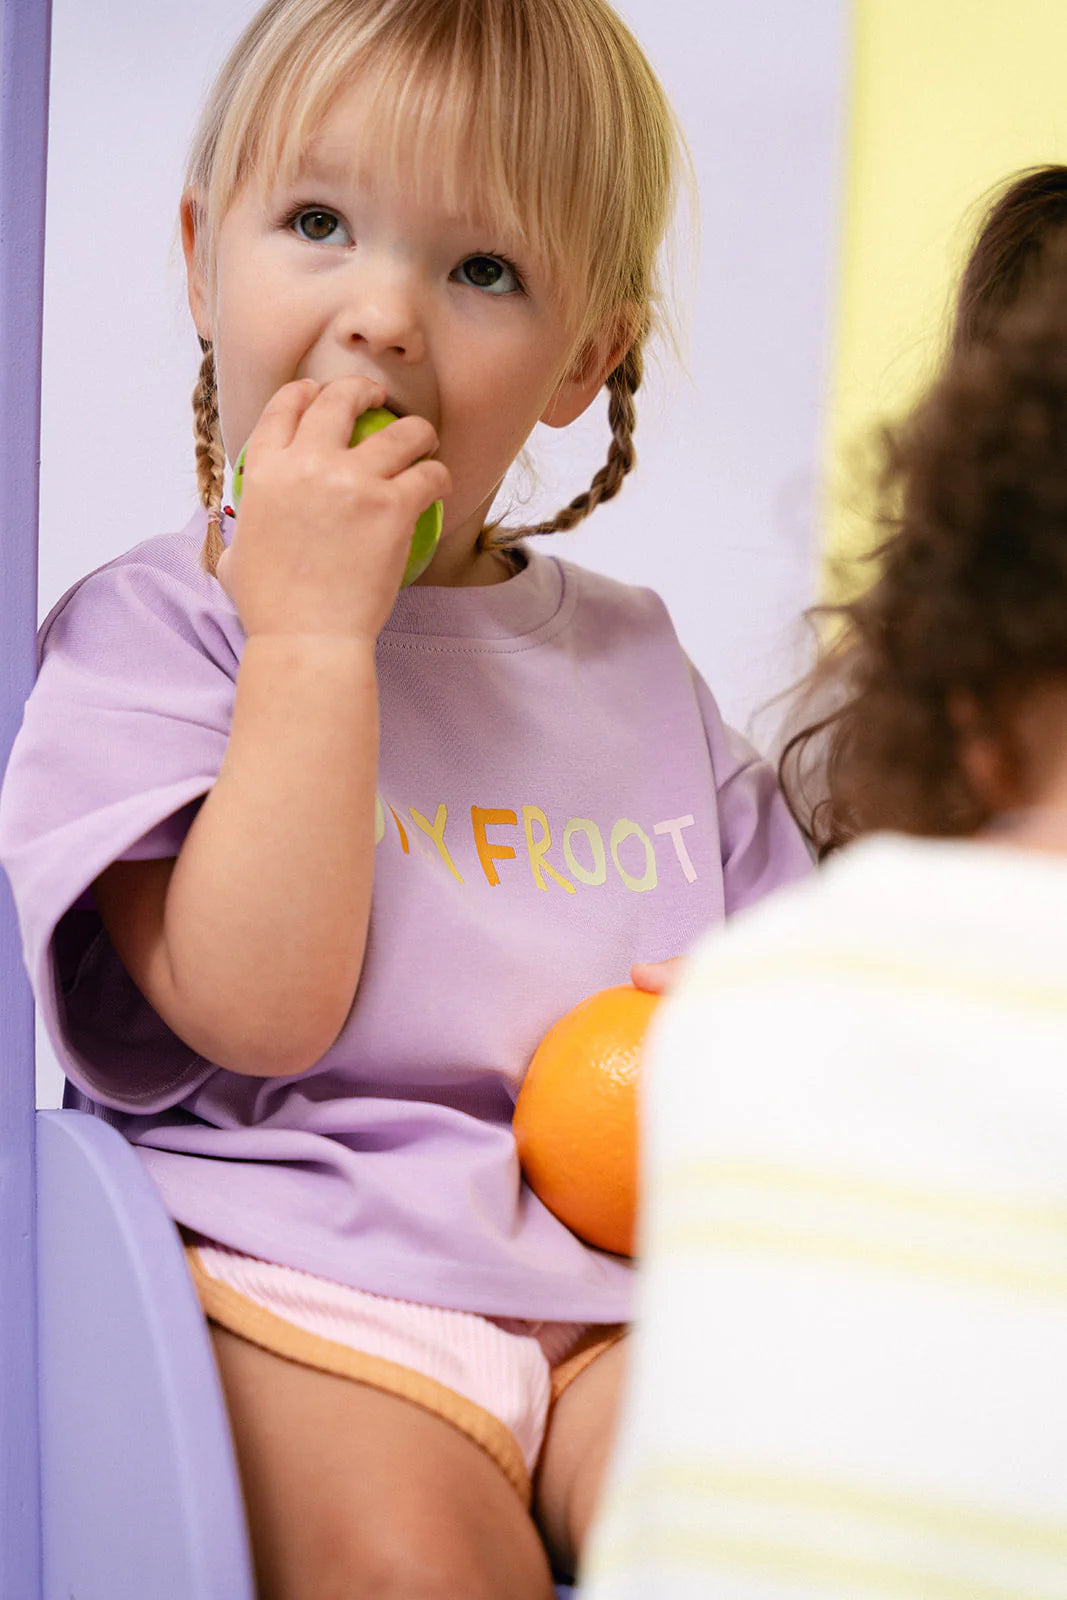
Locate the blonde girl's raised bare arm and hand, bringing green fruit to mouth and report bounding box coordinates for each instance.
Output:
[86,379,448,1077]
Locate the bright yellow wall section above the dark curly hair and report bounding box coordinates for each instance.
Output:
[827,0,1067,594]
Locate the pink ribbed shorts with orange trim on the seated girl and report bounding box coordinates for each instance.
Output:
[182,1229,625,1499]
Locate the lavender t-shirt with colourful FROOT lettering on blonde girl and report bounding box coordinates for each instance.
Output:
[0,517,808,1322]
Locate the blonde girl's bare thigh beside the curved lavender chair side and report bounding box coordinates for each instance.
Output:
[211,1325,553,1600]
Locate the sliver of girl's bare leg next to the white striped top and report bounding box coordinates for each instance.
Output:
[534,1339,629,1573]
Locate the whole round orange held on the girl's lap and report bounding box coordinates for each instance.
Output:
[514,984,659,1256]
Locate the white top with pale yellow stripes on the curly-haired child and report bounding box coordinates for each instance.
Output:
[582,837,1067,1600]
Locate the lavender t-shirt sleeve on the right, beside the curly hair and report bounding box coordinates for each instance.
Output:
[693,670,813,917]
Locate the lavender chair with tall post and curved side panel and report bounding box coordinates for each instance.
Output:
[0,0,569,1600]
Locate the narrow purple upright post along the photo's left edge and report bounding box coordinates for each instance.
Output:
[0,0,51,1600]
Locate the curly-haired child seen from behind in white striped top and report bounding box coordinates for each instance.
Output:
[582,238,1067,1600]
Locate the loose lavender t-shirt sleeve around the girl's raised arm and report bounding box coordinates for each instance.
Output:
[0,541,240,1112]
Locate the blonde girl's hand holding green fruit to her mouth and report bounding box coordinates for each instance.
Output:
[219,378,451,643]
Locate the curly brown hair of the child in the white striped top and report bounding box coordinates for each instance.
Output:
[781,240,1067,856]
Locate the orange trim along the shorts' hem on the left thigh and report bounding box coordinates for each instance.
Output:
[186,1245,534,1504]
